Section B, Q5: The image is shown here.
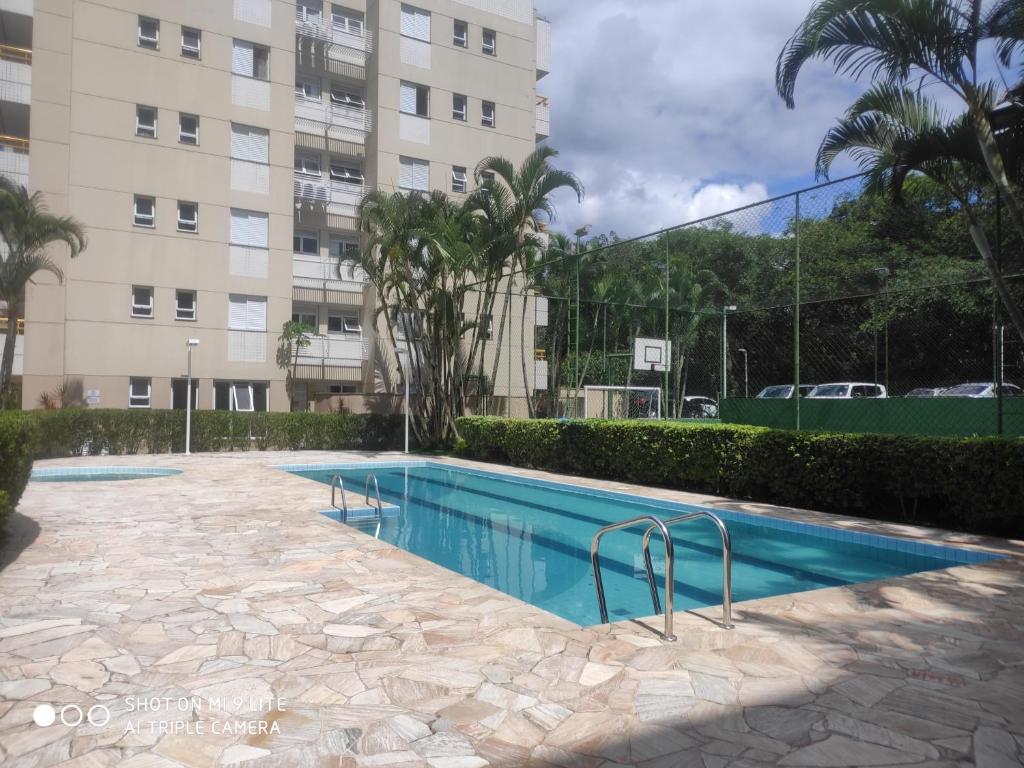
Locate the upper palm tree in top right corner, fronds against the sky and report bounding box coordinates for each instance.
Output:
[775,0,1024,256]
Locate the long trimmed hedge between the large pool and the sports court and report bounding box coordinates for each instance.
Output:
[458,417,1024,537]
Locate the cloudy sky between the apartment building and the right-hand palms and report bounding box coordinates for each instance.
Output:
[536,0,861,237]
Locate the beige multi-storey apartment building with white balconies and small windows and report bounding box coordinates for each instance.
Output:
[0,0,550,411]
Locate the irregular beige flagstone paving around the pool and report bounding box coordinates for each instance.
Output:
[0,453,1024,768]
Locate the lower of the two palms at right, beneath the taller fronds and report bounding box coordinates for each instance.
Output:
[815,84,1024,339]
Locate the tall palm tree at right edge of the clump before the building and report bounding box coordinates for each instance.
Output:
[475,146,584,405]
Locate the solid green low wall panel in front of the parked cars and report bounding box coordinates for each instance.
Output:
[720,397,1024,437]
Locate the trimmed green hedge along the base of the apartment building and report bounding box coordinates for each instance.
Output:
[31,409,402,458]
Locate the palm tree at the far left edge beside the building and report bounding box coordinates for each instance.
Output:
[0,176,86,400]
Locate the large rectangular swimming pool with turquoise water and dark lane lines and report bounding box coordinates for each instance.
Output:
[280,462,995,625]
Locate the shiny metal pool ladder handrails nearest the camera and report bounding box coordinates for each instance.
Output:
[590,512,733,642]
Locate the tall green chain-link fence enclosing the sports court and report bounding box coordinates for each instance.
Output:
[471,177,1024,435]
